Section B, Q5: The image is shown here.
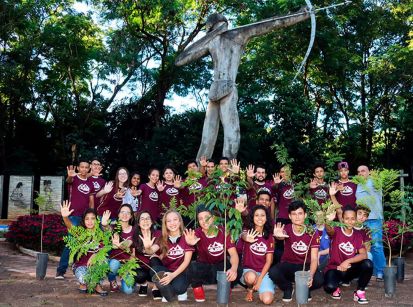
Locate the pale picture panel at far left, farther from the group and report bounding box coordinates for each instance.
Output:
[7,175,33,219]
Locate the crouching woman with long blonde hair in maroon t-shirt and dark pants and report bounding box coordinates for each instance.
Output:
[150,210,194,301]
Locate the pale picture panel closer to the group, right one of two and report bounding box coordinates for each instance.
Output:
[39,176,63,214]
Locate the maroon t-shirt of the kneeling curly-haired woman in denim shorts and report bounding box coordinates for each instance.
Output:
[242,234,274,272]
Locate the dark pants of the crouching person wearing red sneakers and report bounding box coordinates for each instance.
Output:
[189,261,242,288]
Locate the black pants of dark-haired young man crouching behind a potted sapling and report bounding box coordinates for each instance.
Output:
[269,262,323,291]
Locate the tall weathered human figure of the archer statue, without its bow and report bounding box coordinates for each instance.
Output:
[175,9,310,160]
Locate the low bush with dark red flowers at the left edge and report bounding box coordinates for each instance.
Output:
[5,214,67,255]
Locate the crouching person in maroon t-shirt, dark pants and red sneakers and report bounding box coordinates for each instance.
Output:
[185,206,239,302]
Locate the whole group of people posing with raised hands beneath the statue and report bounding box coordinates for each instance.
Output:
[56,157,385,304]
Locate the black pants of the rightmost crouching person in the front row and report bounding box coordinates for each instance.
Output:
[324,259,373,293]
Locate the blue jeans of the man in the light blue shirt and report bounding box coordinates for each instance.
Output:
[365,219,386,277]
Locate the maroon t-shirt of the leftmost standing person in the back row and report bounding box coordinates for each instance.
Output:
[68,175,95,216]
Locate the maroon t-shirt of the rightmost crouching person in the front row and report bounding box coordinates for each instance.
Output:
[325,227,364,271]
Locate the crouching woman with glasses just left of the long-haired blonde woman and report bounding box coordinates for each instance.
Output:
[134,211,162,300]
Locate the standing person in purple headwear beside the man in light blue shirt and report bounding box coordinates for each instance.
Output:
[330,161,357,221]
